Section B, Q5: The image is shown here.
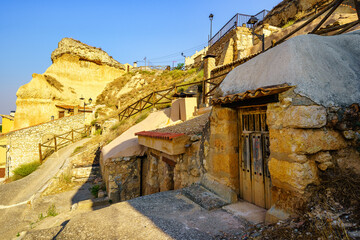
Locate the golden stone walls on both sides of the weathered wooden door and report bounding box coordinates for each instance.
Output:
[207,89,360,221]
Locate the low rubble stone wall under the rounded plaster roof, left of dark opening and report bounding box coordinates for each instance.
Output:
[100,156,142,202]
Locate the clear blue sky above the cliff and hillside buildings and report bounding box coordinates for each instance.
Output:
[0,0,280,119]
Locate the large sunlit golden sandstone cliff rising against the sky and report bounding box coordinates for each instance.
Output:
[14,38,125,129]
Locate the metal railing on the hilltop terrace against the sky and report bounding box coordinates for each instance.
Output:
[209,9,269,47]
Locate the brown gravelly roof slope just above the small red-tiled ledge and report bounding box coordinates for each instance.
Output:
[154,113,210,135]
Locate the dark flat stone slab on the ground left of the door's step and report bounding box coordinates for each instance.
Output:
[181,184,228,210]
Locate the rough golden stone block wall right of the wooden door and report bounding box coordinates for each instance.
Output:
[267,90,360,212]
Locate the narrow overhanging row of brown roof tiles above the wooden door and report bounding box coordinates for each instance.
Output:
[211,84,292,105]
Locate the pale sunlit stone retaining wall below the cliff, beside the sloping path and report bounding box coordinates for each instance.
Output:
[4,114,84,175]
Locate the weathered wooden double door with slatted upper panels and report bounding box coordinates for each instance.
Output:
[238,107,271,209]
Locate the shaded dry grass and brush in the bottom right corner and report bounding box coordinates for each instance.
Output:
[256,168,360,240]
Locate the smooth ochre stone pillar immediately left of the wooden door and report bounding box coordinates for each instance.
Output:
[203,106,239,202]
